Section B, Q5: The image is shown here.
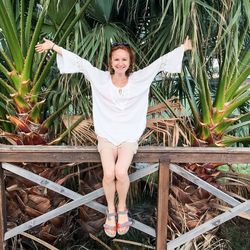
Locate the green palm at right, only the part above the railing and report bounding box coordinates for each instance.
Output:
[144,1,250,146]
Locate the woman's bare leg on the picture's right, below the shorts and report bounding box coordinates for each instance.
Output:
[115,147,134,233]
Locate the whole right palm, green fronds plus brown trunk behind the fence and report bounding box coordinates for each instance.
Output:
[141,1,250,246]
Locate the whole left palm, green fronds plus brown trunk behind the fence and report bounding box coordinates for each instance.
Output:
[0,0,96,249]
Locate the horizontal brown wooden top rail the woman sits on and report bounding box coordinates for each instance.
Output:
[0,146,250,163]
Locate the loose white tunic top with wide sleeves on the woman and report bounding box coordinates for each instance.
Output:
[57,45,184,145]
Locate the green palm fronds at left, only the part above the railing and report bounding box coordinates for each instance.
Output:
[0,0,90,145]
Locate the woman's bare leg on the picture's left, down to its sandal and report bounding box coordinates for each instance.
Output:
[100,148,117,234]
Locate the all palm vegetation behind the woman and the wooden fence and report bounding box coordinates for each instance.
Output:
[0,0,250,250]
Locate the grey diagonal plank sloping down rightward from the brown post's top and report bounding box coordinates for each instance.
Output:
[170,164,250,214]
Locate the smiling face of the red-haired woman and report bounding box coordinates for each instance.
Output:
[111,49,130,75]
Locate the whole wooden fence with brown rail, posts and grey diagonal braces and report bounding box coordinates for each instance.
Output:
[0,145,250,250]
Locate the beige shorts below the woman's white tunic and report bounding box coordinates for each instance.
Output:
[97,136,138,154]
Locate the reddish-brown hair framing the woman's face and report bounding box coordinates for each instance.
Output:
[108,44,135,76]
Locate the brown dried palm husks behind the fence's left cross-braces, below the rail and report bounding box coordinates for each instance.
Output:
[6,164,81,246]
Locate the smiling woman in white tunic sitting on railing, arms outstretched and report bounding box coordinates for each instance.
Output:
[36,38,192,237]
